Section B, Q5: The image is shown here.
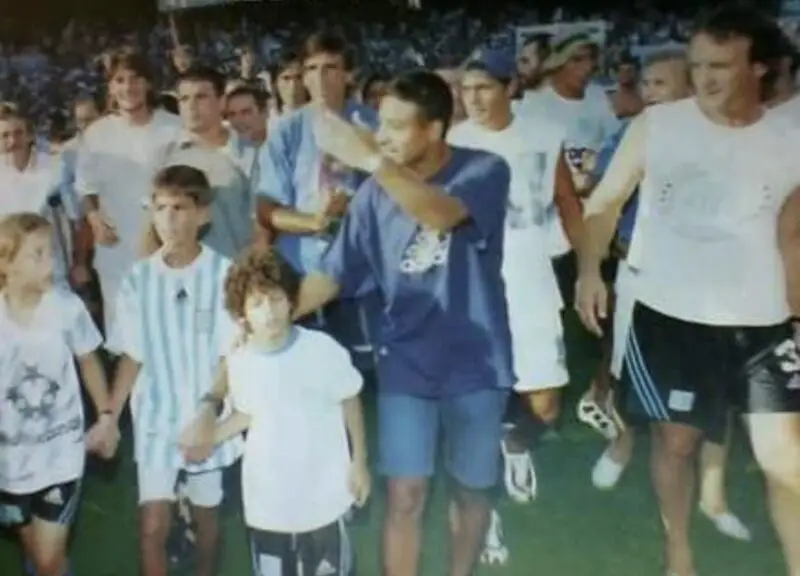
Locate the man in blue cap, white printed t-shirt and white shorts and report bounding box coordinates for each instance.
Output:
[447,50,583,563]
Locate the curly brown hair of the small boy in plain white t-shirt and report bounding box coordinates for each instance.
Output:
[225,246,300,320]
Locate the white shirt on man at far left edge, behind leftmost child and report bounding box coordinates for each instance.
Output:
[0,150,72,280]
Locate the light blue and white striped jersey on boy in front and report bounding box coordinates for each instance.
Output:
[108,246,242,472]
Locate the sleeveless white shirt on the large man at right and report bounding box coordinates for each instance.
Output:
[627,98,800,326]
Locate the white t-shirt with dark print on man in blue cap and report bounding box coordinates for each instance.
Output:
[447,116,564,322]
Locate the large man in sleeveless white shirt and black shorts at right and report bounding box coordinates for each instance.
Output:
[580,7,800,576]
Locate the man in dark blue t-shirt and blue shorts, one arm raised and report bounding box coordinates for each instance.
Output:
[297,72,515,576]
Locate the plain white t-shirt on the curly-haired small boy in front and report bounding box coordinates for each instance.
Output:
[228,328,362,533]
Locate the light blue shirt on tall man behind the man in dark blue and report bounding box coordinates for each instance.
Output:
[256,102,378,274]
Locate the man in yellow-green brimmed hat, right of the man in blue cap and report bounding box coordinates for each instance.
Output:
[517,33,619,306]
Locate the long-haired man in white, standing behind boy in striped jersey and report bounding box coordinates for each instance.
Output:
[75,51,181,326]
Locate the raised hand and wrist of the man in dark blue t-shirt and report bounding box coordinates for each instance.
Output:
[314,108,379,172]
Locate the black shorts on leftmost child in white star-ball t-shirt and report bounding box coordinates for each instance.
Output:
[0,480,81,527]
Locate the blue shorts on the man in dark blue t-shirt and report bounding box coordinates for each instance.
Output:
[378,388,508,490]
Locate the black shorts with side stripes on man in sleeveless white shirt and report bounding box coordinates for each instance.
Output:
[621,303,800,442]
